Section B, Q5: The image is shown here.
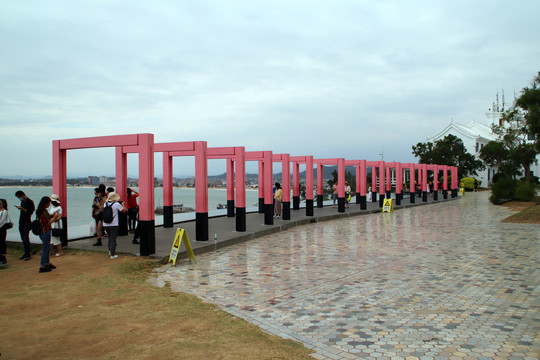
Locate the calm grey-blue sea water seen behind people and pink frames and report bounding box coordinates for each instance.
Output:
[0,186,259,242]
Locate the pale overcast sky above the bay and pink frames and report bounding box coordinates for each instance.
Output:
[0,0,540,177]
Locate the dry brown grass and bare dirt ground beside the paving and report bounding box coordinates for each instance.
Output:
[0,248,312,359]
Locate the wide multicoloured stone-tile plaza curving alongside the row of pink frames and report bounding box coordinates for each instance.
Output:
[150,192,540,360]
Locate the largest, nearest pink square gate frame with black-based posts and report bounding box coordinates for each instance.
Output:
[53,134,155,256]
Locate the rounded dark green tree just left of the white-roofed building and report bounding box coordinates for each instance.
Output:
[412,134,484,177]
